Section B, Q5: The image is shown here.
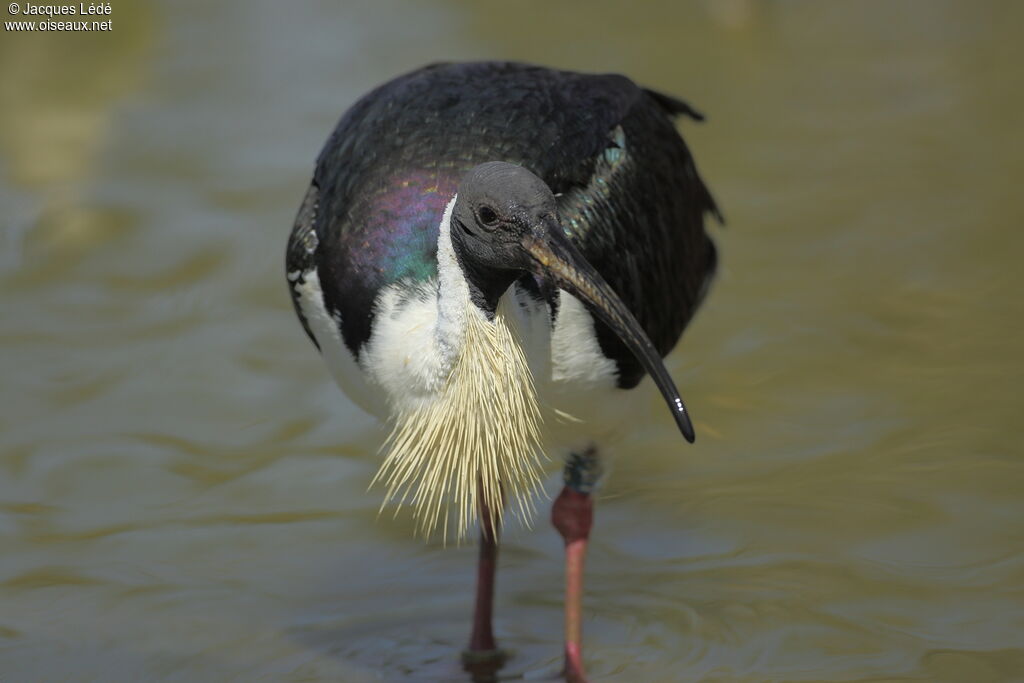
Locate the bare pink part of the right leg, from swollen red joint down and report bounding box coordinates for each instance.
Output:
[551,485,594,683]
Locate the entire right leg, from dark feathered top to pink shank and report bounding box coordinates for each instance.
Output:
[551,447,600,683]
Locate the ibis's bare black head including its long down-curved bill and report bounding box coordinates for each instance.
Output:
[450,162,694,442]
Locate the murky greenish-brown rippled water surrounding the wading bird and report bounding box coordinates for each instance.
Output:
[0,0,1024,683]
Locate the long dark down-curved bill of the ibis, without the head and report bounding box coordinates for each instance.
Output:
[522,216,694,443]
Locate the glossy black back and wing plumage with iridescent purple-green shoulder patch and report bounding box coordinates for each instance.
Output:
[288,62,718,387]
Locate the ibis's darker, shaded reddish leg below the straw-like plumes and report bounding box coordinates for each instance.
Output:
[463,485,505,673]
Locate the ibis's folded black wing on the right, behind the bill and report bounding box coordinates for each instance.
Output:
[559,81,721,388]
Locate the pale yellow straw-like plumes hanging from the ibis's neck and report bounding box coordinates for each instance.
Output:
[371,297,543,541]
